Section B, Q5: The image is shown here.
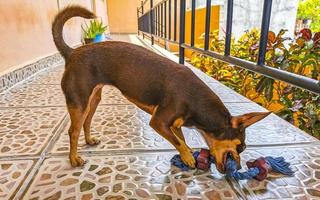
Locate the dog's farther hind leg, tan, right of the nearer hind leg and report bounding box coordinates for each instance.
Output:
[83,85,103,145]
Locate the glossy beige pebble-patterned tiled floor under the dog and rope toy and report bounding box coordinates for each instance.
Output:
[0,35,320,200]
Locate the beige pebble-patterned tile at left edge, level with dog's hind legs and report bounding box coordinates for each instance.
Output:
[0,107,66,158]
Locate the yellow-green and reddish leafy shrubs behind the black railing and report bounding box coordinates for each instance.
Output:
[191,29,320,138]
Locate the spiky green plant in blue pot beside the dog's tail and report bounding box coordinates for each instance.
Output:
[81,20,107,44]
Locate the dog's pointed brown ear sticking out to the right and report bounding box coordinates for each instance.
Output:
[231,112,272,128]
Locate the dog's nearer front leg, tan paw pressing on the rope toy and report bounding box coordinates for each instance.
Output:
[150,108,196,168]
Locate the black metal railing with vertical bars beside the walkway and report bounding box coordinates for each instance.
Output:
[137,0,320,94]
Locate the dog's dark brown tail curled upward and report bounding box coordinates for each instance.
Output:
[52,6,96,59]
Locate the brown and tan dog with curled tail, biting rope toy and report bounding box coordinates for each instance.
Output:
[52,6,270,173]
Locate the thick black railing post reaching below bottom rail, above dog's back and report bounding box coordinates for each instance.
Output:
[179,0,186,64]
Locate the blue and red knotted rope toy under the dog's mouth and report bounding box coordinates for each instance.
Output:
[171,149,294,181]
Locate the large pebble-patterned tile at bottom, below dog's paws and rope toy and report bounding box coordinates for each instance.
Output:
[24,153,237,200]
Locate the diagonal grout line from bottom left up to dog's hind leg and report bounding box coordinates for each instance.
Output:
[13,113,68,200]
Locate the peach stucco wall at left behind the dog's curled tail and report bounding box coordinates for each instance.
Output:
[0,0,107,74]
